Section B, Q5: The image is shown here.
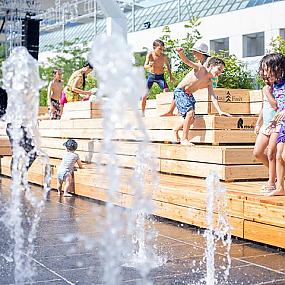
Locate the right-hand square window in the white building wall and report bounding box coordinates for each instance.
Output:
[242,32,264,57]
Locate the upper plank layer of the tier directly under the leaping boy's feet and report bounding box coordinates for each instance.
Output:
[41,137,259,165]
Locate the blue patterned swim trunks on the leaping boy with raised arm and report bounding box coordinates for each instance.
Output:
[174,88,196,118]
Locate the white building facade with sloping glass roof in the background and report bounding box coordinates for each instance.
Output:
[40,0,285,67]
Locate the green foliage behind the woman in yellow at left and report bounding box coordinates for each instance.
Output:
[40,40,96,106]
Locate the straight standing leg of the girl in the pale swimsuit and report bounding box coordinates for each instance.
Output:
[267,133,278,186]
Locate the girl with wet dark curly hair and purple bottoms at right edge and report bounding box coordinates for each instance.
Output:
[259,53,285,196]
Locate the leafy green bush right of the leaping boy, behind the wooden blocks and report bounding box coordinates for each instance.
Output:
[213,51,253,89]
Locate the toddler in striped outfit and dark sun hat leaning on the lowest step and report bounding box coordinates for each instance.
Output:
[57,139,83,197]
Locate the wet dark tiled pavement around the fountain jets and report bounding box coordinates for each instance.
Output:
[0,177,285,285]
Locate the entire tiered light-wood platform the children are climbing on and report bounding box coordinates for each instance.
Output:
[0,89,285,248]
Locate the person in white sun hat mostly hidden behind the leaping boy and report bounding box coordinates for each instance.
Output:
[161,42,211,117]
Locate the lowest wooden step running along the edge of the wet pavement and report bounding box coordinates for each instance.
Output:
[2,158,285,248]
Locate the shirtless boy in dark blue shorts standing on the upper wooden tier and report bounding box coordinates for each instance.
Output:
[142,40,174,116]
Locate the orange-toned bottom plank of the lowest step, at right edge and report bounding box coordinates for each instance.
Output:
[244,220,285,248]
